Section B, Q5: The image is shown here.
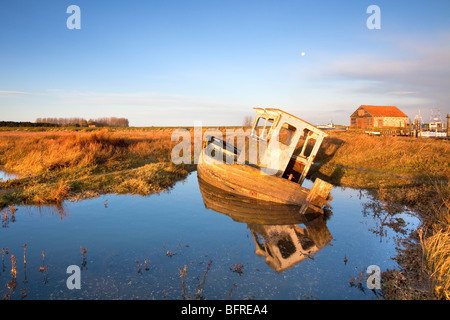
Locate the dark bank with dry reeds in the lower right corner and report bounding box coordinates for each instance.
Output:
[356,181,450,300]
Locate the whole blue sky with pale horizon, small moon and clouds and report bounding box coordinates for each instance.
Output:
[0,0,450,127]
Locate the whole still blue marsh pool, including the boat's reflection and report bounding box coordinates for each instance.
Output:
[0,172,419,300]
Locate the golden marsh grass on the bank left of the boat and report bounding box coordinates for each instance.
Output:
[0,128,194,207]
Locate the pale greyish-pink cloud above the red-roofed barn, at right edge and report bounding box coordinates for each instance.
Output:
[329,35,450,103]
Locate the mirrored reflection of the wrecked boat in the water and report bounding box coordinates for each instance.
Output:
[198,178,332,273]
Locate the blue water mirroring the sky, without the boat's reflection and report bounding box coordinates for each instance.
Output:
[0,173,418,299]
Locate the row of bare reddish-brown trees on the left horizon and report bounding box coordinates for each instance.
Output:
[36,117,129,127]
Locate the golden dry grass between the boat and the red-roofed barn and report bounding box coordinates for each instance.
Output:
[311,132,450,189]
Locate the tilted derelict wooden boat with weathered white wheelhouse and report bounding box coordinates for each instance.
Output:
[197,108,332,207]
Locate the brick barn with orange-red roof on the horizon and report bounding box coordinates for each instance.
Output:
[350,105,408,128]
